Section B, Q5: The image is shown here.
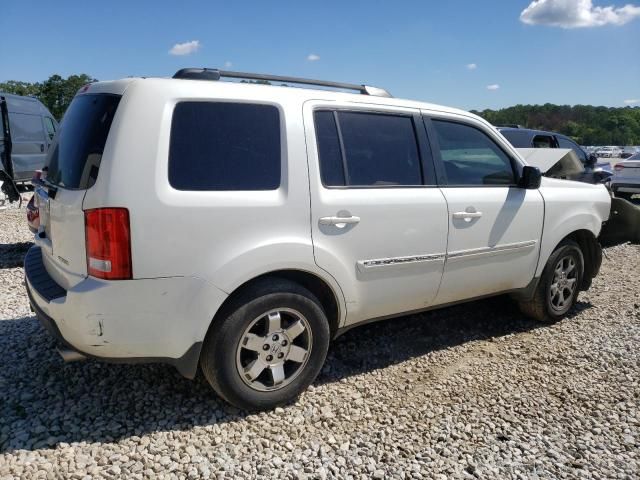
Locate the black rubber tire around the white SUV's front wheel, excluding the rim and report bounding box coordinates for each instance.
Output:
[518,239,584,323]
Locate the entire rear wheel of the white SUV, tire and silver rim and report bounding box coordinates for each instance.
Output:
[200,279,330,410]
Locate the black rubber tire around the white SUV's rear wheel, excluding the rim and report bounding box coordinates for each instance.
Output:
[200,278,330,410]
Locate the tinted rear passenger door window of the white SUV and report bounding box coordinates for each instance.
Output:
[314,111,423,187]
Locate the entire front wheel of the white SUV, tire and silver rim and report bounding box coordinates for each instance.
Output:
[519,240,584,322]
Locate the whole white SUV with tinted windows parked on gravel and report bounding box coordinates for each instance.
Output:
[25,69,610,409]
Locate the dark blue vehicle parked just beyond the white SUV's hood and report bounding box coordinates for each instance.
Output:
[497,127,613,184]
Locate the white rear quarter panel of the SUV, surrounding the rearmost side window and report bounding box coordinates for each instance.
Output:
[84,79,348,324]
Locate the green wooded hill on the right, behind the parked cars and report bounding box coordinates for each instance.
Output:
[473,103,640,145]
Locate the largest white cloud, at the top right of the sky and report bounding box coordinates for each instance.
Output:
[520,0,640,28]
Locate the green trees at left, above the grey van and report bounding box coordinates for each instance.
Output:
[0,73,96,120]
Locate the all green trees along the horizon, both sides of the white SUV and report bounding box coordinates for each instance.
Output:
[0,73,640,145]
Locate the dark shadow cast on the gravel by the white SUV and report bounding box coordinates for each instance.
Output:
[0,297,591,453]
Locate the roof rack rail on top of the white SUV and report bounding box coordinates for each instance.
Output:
[173,68,391,97]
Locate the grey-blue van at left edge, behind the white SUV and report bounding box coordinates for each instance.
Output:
[0,93,58,201]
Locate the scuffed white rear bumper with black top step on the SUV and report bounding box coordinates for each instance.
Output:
[25,246,226,378]
